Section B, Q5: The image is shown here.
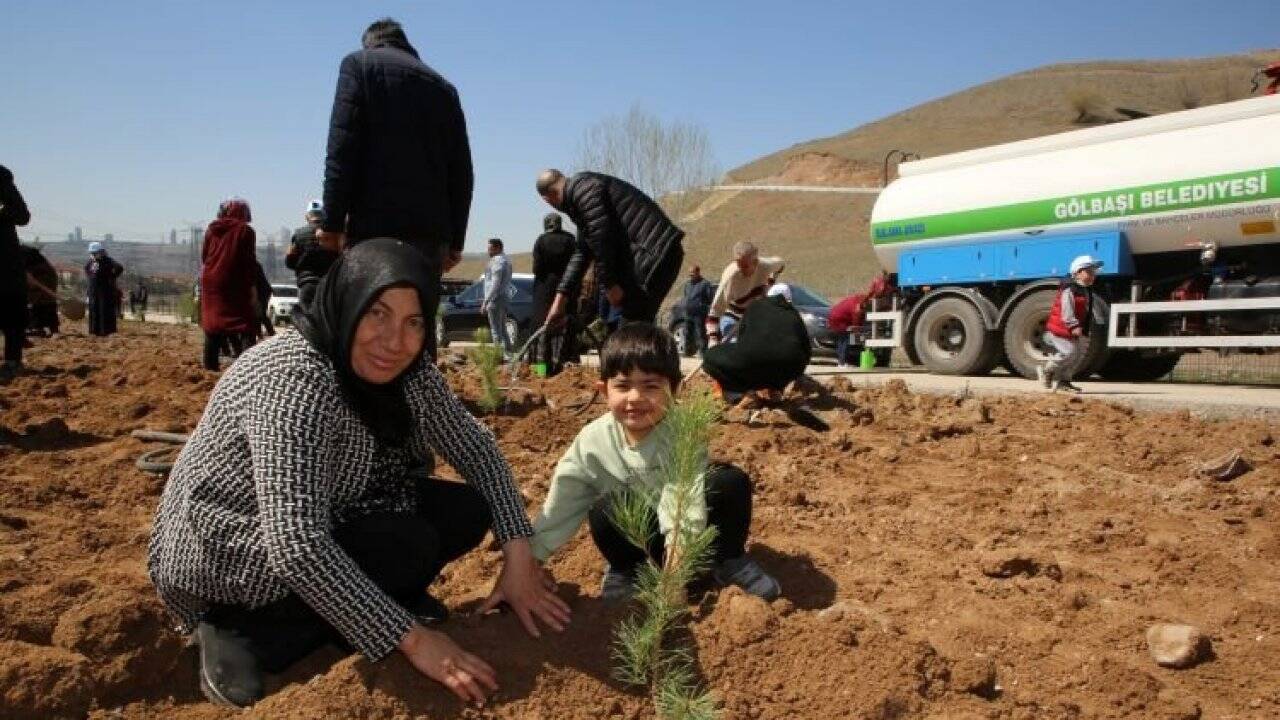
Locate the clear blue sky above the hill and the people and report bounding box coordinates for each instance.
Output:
[0,0,1280,251]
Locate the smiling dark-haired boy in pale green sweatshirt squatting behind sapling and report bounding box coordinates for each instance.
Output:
[532,323,781,601]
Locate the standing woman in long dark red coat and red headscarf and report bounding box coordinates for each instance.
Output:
[200,197,257,370]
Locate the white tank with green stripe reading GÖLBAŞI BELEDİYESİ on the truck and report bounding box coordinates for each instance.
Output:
[872,96,1280,272]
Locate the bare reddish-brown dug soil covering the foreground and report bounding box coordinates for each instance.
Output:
[0,324,1280,720]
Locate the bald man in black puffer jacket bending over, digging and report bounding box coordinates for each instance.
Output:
[536,170,685,323]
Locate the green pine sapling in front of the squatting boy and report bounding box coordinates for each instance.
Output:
[609,393,719,720]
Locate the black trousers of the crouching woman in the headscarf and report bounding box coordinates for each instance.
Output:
[204,478,493,673]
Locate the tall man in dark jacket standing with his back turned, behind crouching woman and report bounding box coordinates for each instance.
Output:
[316,19,475,350]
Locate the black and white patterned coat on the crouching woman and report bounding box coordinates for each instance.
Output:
[147,329,532,659]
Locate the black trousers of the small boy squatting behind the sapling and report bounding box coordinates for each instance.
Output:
[586,465,751,575]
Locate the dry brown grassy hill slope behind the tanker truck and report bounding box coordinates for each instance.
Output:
[682,50,1280,297]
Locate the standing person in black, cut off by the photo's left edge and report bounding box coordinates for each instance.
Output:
[0,165,31,375]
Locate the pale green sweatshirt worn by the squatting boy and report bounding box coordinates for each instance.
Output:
[532,413,707,560]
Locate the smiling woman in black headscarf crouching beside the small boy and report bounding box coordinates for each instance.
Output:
[148,240,568,706]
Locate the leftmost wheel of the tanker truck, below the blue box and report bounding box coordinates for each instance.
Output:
[911,297,1000,375]
